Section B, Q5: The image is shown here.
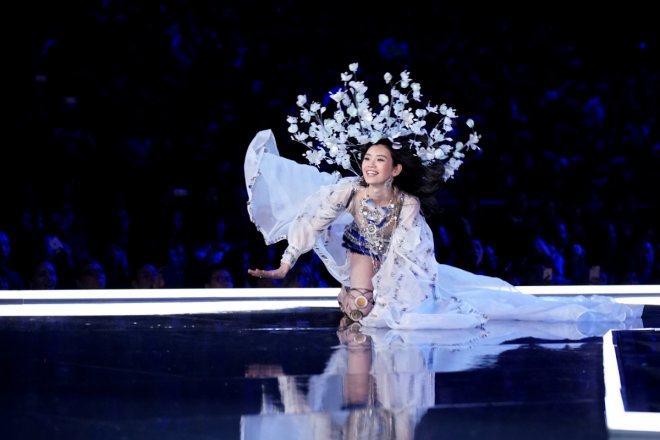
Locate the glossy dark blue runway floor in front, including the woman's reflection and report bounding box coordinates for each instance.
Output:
[0,292,660,440]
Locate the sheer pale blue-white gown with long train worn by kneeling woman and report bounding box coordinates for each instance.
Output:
[245,130,643,329]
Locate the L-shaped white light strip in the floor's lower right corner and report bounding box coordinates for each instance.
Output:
[603,329,660,438]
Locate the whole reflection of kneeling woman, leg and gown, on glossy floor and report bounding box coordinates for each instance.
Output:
[241,321,636,440]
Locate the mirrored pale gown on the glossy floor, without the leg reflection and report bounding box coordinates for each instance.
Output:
[241,320,638,440]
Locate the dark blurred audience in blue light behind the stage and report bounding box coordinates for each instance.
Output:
[0,6,660,290]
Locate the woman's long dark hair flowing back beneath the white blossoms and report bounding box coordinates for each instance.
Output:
[360,136,445,217]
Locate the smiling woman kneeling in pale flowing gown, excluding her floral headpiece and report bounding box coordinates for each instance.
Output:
[246,130,642,329]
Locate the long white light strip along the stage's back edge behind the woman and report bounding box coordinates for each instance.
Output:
[0,285,660,316]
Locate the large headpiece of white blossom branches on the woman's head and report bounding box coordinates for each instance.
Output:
[287,63,481,180]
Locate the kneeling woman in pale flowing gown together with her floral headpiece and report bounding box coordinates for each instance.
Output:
[245,65,641,329]
